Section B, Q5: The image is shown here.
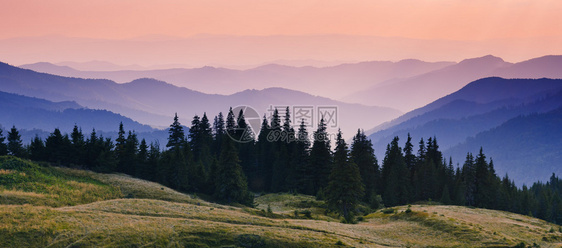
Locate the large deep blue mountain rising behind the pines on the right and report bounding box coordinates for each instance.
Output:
[369,77,562,184]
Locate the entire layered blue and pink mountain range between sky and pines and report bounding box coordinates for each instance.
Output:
[0,56,562,184]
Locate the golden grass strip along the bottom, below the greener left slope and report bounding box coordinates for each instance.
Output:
[4,199,562,247]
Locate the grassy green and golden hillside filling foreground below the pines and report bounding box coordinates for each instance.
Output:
[0,157,562,247]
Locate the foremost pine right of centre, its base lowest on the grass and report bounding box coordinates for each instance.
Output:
[326,131,364,223]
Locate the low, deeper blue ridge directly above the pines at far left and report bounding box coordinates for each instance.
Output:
[0,91,175,144]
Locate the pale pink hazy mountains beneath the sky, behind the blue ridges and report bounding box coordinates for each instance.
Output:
[22,55,562,112]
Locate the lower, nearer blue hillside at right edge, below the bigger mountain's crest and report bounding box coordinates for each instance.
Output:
[443,105,562,186]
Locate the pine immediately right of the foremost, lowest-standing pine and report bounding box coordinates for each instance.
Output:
[351,130,380,205]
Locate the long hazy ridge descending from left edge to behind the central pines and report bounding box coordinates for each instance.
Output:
[0,61,401,139]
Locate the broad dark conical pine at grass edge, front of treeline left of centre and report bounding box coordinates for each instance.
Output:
[214,139,253,206]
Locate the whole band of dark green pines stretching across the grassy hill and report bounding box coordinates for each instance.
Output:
[0,109,562,223]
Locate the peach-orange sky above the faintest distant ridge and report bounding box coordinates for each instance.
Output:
[0,0,562,66]
